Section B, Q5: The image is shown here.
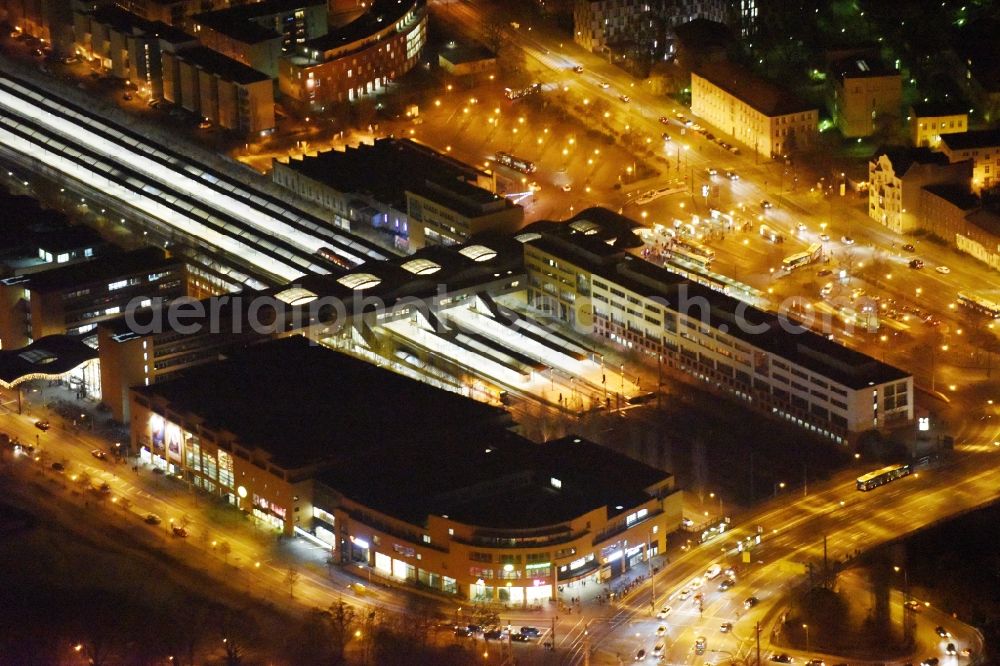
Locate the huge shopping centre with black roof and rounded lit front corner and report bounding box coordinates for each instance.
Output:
[131,337,681,605]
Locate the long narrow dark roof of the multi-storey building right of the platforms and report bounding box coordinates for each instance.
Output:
[519,216,908,389]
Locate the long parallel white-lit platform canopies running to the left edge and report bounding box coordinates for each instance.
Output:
[0,76,386,282]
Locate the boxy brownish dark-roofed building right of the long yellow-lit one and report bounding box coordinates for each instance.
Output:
[829,55,903,138]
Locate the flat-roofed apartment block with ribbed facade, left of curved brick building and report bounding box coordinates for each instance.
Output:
[163,46,274,135]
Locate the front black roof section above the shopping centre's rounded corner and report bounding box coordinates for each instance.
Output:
[318,430,670,530]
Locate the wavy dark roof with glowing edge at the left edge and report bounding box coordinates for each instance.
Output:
[0,335,97,388]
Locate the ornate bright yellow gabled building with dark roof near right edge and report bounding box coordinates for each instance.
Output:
[868,147,972,234]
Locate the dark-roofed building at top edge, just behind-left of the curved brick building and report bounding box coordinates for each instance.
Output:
[190,0,328,79]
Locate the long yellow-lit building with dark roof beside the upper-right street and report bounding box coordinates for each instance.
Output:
[691,62,819,158]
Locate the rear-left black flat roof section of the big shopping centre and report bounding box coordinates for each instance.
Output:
[133,336,507,470]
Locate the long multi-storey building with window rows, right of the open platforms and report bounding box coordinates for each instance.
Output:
[517,209,913,443]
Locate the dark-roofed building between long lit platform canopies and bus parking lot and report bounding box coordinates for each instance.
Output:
[272,139,524,251]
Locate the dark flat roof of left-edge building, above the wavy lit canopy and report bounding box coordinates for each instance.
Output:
[0,247,178,292]
